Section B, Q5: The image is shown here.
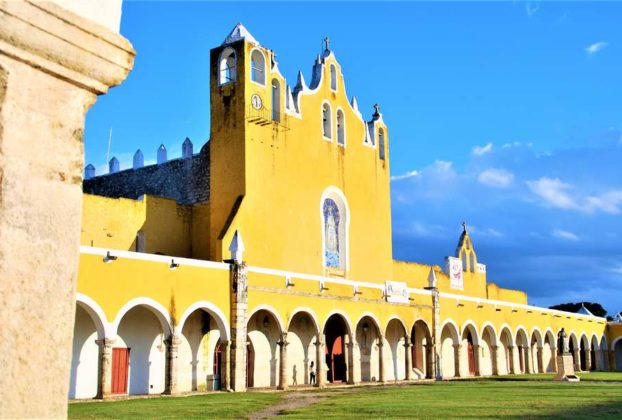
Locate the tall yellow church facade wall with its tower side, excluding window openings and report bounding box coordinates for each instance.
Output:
[210,43,392,282]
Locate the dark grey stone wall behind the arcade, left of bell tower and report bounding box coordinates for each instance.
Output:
[82,142,210,204]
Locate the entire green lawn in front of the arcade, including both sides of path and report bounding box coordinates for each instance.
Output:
[69,372,622,419]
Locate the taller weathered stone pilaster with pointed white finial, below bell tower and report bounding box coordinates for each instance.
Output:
[227,243,248,392]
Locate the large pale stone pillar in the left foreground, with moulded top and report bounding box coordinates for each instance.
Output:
[0,0,134,418]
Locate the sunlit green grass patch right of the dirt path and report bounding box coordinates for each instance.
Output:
[287,381,622,419]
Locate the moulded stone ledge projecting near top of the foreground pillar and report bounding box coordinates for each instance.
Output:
[0,0,135,94]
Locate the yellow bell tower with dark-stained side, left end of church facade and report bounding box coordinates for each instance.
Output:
[209,23,272,261]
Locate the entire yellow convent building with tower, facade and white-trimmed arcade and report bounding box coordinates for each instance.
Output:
[69,25,622,398]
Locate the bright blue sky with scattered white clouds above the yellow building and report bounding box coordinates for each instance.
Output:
[85,1,622,312]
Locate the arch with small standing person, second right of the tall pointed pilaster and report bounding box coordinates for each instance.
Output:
[285,308,320,385]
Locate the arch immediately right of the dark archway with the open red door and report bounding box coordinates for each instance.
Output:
[354,312,382,382]
